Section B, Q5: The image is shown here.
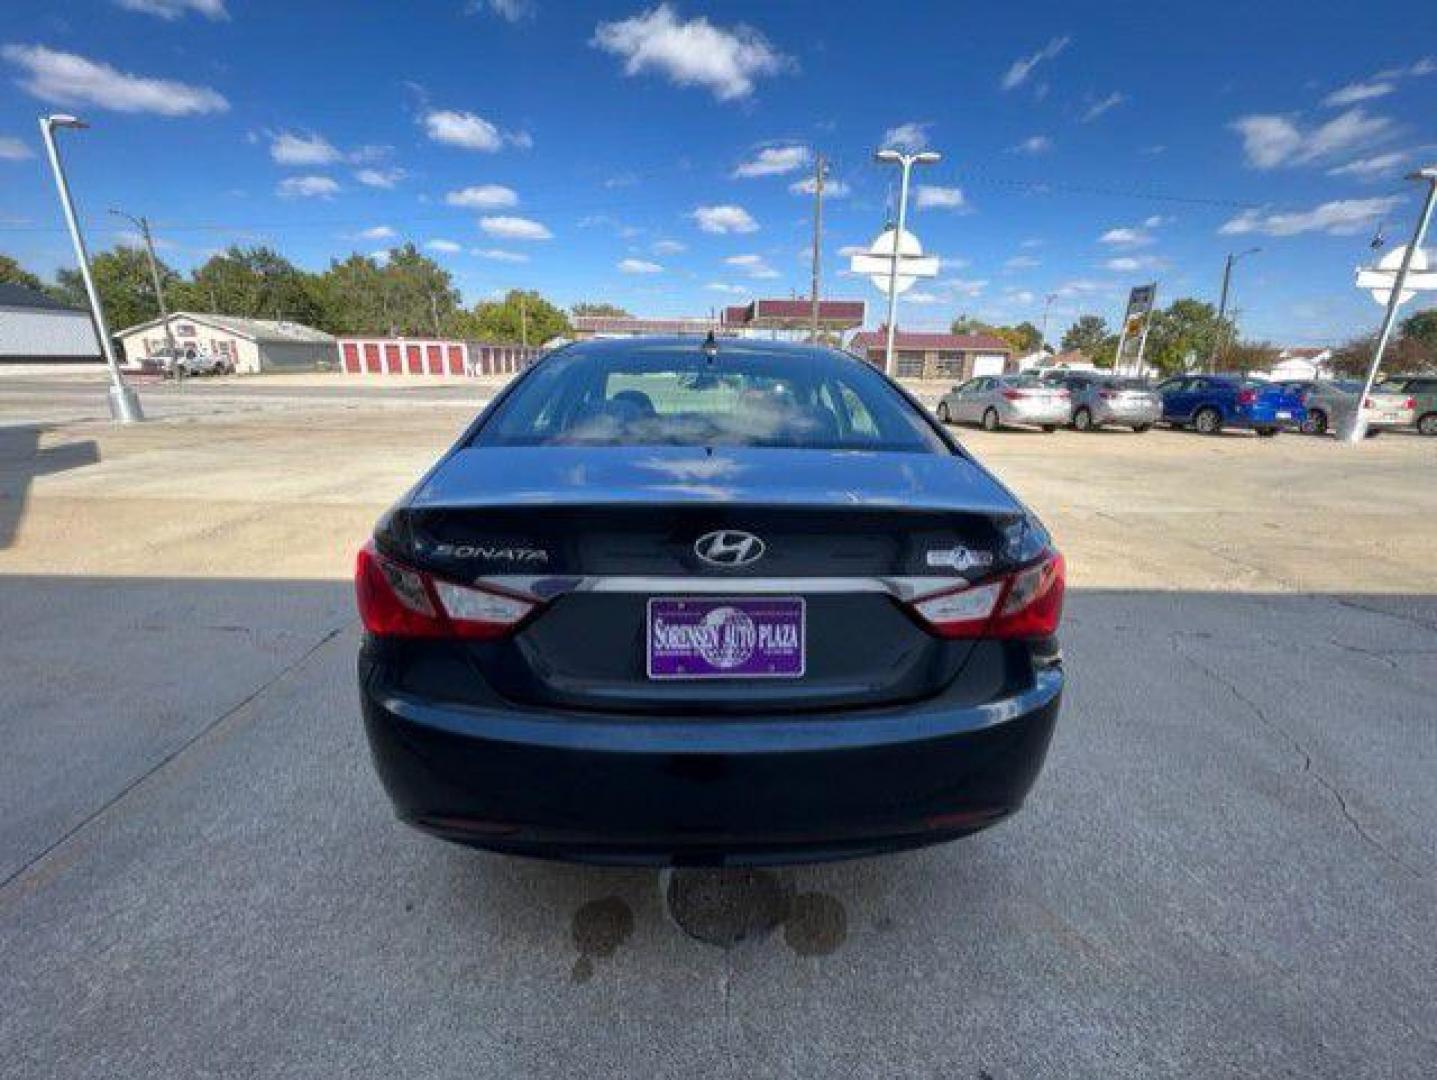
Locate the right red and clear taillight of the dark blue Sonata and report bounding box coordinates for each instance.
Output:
[912,551,1066,638]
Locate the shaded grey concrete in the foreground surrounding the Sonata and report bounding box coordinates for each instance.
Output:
[0,576,1437,1076]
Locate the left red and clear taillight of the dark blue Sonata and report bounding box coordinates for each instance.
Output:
[355,540,535,641]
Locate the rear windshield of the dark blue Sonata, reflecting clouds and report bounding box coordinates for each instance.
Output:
[471,342,948,454]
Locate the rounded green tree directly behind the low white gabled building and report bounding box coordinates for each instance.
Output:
[167,246,322,326]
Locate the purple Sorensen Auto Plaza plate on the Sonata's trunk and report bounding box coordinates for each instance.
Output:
[645,596,806,679]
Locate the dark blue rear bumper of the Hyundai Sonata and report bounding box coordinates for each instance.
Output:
[361,658,1063,865]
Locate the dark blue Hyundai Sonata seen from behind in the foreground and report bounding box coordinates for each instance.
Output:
[356,339,1065,865]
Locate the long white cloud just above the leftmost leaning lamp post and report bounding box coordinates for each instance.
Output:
[3,45,230,116]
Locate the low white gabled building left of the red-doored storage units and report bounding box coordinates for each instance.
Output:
[115,312,335,375]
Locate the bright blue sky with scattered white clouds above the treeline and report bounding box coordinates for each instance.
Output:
[0,0,1437,345]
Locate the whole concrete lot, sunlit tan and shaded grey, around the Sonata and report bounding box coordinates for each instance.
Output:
[0,378,1437,1080]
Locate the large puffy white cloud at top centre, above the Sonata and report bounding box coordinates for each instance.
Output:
[589,3,793,101]
